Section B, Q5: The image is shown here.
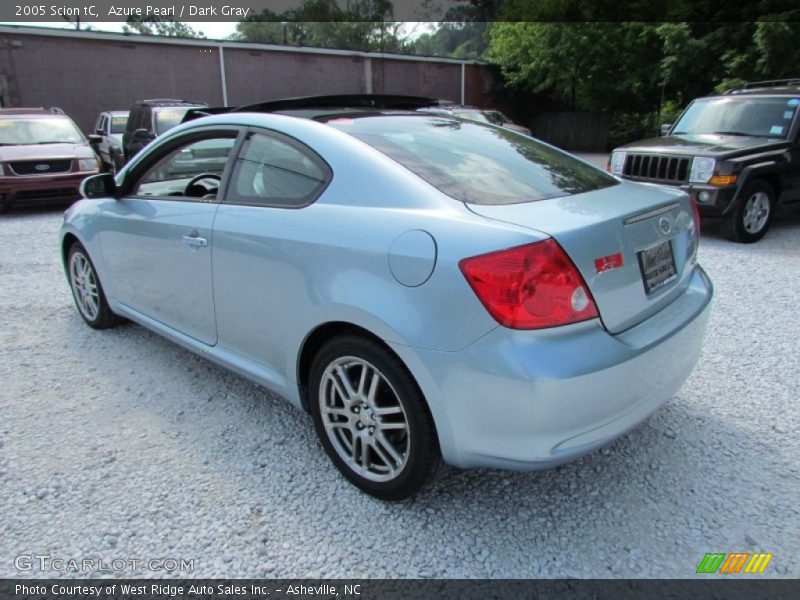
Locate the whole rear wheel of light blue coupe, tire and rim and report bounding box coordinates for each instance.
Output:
[309,336,440,500]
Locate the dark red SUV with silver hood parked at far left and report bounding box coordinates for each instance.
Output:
[0,108,99,212]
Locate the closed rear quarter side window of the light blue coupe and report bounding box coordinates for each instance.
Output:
[225,133,330,208]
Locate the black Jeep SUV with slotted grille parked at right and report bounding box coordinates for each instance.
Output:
[609,79,800,243]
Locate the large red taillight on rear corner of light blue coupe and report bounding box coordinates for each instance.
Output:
[459,239,597,329]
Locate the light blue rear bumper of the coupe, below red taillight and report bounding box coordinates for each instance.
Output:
[393,267,713,470]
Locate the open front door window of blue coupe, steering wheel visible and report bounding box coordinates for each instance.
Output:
[131,132,236,201]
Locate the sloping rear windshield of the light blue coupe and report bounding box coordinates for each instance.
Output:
[328,115,617,204]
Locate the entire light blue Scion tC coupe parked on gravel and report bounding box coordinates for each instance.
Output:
[61,96,712,499]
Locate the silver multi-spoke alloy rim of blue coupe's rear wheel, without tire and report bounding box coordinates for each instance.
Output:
[319,356,411,482]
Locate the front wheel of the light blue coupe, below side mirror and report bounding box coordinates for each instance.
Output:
[67,242,122,329]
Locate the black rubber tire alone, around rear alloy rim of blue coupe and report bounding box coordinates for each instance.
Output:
[308,335,442,501]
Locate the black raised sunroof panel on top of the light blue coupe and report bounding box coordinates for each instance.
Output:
[181,94,449,123]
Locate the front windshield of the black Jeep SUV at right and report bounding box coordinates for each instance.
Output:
[672,96,800,138]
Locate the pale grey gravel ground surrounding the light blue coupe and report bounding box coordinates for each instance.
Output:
[0,210,800,578]
